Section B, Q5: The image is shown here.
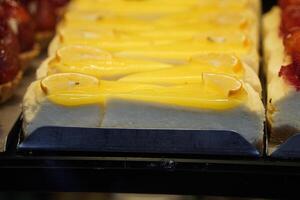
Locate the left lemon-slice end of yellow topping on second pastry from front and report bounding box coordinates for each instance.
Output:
[47,46,173,79]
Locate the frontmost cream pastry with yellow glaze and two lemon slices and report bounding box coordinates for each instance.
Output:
[23,73,264,144]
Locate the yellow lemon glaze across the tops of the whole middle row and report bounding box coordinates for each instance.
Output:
[41,0,257,110]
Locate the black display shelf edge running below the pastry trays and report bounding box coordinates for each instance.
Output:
[0,0,300,198]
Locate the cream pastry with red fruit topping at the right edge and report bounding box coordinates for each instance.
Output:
[264,4,300,144]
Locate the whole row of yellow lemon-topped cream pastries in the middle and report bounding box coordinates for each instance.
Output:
[23,0,265,145]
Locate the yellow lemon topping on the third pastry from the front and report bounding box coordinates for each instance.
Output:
[53,33,248,61]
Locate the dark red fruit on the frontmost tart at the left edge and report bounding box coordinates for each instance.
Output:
[0,11,20,84]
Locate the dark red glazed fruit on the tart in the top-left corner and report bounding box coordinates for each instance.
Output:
[1,0,35,52]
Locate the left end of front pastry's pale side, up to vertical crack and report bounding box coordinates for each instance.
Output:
[23,81,103,136]
